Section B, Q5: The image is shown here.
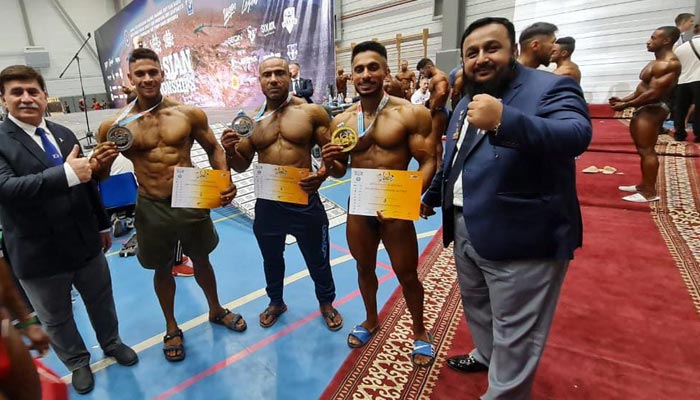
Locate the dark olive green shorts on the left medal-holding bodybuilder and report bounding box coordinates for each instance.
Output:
[134,195,219,269]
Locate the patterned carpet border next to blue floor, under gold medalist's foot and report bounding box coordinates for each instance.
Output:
[320,231,463,400]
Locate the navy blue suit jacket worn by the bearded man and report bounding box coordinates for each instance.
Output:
[423,65,592,261]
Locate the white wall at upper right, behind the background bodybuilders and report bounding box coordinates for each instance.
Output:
[513,0,695,103]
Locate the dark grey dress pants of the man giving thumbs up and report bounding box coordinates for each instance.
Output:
[20,253,121,371]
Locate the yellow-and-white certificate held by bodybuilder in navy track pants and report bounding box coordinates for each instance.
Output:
[253,163,310,204]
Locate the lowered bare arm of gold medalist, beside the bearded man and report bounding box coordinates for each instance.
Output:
[405,105,437,193]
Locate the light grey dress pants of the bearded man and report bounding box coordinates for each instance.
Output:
[454,211,569,400]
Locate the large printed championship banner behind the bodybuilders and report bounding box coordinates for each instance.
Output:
[95,0,335,108]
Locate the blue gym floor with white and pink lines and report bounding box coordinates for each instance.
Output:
[45,163,440,400]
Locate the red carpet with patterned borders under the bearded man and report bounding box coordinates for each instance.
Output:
[321,120,700,400]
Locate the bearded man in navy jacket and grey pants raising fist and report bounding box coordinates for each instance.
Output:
[421,18,592,399]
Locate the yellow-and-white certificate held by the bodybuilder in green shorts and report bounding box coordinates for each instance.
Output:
[170,167,231,208]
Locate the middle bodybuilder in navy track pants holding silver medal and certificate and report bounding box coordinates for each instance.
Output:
[221,57,343,331]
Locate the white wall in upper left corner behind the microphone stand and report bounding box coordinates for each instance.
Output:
[0,0,115,97]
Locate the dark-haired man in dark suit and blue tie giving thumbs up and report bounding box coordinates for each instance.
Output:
[0,65,138,393]
